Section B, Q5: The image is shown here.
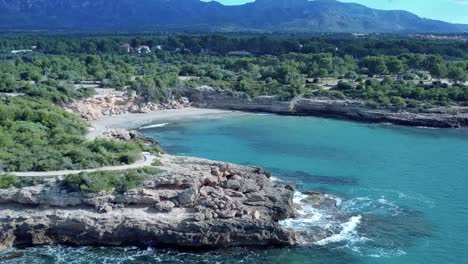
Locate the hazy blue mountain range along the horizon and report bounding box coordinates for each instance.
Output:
[0,0,468,33]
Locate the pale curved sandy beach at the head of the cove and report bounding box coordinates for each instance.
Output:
[86,107,247,139]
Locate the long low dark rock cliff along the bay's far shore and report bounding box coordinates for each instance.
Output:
[181,87,468,128]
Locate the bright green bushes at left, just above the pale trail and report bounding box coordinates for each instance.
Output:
[0,96,144,172]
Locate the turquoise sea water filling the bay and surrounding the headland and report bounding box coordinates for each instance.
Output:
[3,114,468,264]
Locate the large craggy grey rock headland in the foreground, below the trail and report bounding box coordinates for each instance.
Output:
[0,155,296,250]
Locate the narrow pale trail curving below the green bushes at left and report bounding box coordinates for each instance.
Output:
[10,152,156,178]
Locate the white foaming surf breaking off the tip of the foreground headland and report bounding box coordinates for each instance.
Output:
[280,192,406,258]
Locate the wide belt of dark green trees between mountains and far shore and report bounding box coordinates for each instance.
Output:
[0,35,468,108]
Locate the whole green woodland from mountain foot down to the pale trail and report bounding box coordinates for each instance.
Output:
[0,35,468,171]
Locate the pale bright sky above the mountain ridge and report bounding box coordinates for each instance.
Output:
[204,0,468,24]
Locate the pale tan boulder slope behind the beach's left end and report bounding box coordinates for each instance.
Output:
[64,91,190,120]
